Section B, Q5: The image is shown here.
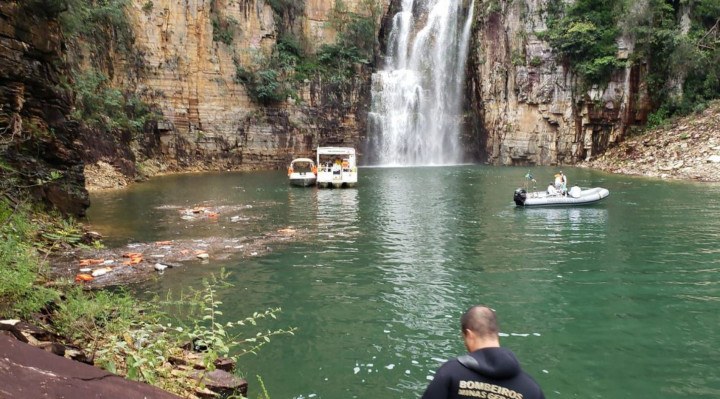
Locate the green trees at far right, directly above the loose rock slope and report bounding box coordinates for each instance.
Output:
[625,0,720,124]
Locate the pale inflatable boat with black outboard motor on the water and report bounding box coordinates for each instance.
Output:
[513,186,610,206]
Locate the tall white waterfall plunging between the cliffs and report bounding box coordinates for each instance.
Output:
[368,0,474,166]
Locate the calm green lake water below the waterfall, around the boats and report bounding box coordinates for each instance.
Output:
[89,166,720,399]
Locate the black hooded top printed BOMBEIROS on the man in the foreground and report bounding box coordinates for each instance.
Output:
[422,348,545,399]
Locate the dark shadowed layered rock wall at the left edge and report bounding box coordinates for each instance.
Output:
[0,1,89,215]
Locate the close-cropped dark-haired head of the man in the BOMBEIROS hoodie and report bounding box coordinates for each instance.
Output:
[460,305,500,352]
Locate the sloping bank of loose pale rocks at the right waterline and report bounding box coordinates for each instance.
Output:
[578,102,720,182]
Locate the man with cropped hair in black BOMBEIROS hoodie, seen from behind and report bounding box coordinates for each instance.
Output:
[422,306,545,399]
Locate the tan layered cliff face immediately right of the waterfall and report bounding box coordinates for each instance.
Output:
[465,0,649,165]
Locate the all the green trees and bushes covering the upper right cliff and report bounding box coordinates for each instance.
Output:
[539,0,720,125]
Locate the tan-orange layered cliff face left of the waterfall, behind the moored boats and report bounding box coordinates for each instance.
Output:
[122,0,376,169]
